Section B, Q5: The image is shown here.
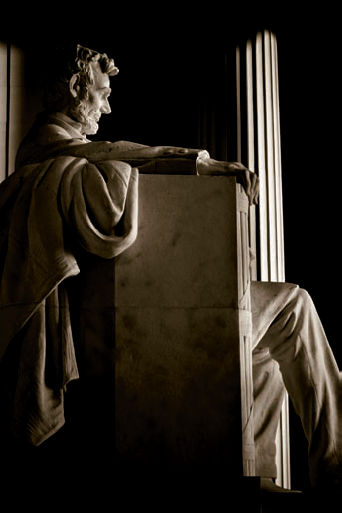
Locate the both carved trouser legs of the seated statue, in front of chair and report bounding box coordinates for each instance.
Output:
[252,283,340,485]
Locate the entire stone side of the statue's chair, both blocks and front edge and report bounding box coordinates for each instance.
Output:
[113,175,254,476]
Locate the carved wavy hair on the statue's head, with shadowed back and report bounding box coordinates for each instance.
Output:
[43,45,119,112]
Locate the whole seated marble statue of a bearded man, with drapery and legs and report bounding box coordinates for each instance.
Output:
[0,45,342,491]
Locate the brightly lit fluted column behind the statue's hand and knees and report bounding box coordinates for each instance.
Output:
[236,30,290,487]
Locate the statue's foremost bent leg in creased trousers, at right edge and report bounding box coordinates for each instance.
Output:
[258,288,341,485]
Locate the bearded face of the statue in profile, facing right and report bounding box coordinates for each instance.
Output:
[82,62,111,135]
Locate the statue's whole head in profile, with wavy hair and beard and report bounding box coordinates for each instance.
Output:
[43,45,119,134]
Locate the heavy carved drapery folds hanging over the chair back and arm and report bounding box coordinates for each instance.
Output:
[0,157,138,445]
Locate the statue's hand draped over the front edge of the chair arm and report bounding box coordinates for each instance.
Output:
[197,158,259,205]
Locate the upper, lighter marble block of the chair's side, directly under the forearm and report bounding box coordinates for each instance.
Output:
[115,175,237,308]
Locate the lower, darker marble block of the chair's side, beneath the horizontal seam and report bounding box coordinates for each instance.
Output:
[116,307,242,475]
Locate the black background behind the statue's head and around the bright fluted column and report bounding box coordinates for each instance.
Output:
[2,4,342,487]
